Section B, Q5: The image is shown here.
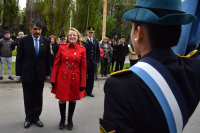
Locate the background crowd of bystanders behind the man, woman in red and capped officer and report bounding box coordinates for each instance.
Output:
[0,27,138,80]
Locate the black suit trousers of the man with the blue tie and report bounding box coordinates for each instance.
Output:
[22,80,44,121]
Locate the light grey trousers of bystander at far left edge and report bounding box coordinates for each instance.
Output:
[1,57,12,77]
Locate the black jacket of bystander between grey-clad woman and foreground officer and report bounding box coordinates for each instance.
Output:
[115,43,129,61]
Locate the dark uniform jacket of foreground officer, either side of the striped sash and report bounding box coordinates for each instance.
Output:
[100,47,200,133]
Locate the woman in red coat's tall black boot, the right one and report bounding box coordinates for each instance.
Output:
[67,102,76,130]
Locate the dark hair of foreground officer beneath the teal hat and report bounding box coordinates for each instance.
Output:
[133,21,181,49]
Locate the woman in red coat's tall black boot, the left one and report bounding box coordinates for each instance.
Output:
[59,103,66,130]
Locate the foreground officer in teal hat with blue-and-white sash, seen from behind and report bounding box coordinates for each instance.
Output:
[100,0,200,133]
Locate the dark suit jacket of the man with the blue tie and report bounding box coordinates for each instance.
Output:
[16,35,50,83]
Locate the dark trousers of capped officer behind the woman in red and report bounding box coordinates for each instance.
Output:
[85,67,95,95]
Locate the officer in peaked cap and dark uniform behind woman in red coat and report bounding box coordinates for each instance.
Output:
[83,27,100,97]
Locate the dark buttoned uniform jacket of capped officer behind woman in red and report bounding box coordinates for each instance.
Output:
[83,39,100,67]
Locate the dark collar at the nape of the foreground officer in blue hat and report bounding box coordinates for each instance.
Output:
[143,47,176,60]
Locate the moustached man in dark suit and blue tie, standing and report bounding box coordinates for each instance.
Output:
[16,19,50,128]
